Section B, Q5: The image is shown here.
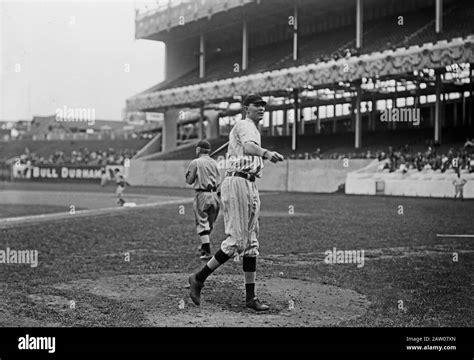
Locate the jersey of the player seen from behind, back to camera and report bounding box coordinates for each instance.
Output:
[186,155,221,190]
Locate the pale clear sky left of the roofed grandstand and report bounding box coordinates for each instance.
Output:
[0,0,165,120]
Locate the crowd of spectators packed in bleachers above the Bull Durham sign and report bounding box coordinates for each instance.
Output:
[19,147,137,166]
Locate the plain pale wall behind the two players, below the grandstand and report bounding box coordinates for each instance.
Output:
[128,159,373,193]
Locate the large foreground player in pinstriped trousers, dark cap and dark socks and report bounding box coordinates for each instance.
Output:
[189,95,283,311]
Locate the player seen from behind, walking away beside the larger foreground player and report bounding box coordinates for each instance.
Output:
[186,140,221,260]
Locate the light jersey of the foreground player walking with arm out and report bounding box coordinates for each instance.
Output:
[226,118,263,178]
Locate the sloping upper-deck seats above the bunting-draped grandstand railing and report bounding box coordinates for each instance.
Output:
[140,1,474,92]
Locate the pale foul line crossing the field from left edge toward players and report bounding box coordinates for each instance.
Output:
[0,198,193,229]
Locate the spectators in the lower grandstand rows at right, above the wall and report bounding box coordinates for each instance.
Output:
[290,138,474,173]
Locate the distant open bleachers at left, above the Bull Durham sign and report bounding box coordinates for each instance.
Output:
[0,115,157,165]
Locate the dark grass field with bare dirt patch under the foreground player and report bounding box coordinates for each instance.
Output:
[0,183,474,327]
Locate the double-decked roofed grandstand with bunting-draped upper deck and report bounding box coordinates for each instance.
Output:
[127,0,474,164]
